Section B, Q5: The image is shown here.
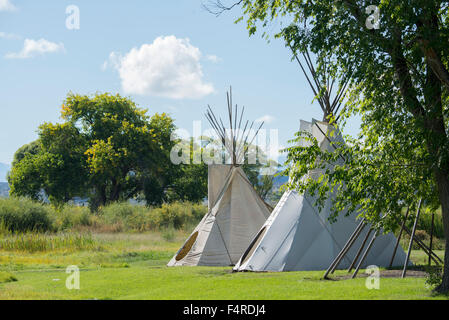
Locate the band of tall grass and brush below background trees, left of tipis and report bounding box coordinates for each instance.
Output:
[0,199,207,234]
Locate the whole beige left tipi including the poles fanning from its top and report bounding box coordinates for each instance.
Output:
[168,88,271,266]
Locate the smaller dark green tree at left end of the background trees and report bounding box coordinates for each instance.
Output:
[8,123,86,205]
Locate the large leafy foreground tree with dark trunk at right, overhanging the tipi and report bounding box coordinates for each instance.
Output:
[228,0,449,292]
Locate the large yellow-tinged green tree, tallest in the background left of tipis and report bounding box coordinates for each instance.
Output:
[62,94,175,206]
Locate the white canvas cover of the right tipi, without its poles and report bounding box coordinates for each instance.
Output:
[234,121,405,271]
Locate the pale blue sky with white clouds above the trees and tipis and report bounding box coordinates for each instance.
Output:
[0,0,359,163]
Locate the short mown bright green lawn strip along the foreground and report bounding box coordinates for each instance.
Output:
[0,264,440,300]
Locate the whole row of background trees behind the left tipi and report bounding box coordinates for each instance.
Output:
[8,93,273,211]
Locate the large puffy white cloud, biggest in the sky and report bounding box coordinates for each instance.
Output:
[107,36,214,99]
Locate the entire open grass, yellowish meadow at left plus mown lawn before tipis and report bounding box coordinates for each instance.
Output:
[0,232,446,300]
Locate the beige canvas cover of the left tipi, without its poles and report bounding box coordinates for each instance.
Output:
[168,165,270,266]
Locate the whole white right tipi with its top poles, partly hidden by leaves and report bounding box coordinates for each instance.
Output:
[234,51,405,271]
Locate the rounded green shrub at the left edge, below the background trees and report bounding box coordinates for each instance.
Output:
[0,198,55,232]
